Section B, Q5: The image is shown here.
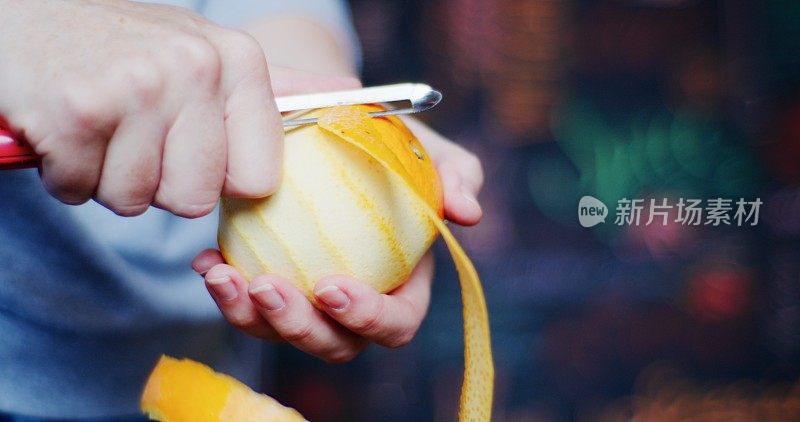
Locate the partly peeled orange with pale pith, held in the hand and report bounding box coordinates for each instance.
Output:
[218,106,442,300]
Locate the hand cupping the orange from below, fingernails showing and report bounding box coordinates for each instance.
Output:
[192,120,483,362]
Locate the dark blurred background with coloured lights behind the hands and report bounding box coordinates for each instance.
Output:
[267,0,800,421]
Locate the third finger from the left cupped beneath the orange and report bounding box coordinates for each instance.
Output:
[250,275,367,363]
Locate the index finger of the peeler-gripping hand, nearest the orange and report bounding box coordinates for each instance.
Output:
[209,29,283,198]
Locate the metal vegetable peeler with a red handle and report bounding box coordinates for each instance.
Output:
[0,83,442,170]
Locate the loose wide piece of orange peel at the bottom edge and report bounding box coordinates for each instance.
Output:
[141,356,305,422]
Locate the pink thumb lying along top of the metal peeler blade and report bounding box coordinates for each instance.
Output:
[269,65,361,96]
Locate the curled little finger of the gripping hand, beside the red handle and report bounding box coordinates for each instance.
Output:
[36,133,105,205]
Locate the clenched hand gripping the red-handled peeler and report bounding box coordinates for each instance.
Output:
[0,0,353,217]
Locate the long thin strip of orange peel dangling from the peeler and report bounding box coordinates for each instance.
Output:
[318,107,494,421]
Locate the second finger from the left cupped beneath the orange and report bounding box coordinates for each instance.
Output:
[205,264,279,340]
